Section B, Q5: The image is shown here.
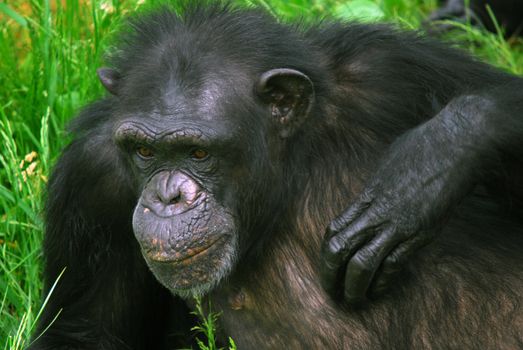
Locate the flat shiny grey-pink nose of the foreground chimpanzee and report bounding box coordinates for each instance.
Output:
[142,171,204,216]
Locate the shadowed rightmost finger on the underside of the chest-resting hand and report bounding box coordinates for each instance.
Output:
[369,231,434,298]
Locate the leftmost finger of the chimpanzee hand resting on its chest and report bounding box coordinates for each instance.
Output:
[320,217,374,296]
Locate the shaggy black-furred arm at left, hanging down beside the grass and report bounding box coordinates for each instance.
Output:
[30,103,185,349]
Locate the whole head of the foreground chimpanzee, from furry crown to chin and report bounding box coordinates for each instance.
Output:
[98,4,320,296]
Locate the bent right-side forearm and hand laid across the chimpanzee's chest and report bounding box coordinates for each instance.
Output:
[321,78,523,303]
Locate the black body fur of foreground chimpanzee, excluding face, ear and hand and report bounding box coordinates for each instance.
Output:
[30,4,523,349]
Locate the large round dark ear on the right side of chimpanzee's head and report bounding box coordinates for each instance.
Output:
[257,68,314,138]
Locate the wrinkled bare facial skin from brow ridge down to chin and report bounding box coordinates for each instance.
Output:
[111,105,246,297]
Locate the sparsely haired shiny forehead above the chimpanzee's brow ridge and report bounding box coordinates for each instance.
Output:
[113,63,255,139]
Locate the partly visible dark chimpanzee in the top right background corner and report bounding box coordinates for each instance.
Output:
[429,0,523,37]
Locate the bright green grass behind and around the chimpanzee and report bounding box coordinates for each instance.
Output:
[0,0,523,349]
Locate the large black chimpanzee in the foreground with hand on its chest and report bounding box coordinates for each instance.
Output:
[31,2,523,349]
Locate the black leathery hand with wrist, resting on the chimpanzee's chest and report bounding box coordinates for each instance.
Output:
[321,99,490,304]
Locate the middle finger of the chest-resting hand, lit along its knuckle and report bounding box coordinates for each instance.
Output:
[344,229,398,304]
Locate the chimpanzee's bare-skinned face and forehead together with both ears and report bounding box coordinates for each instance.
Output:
[103,63,313,296]
